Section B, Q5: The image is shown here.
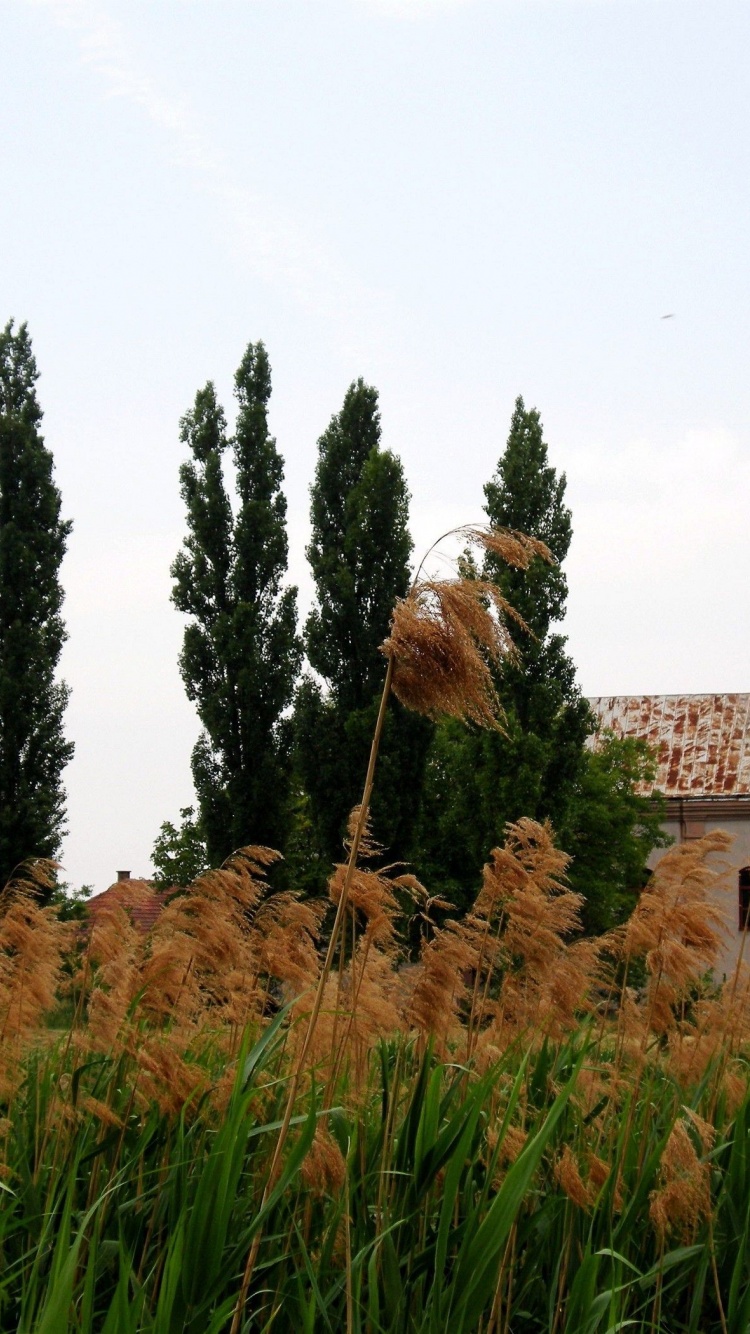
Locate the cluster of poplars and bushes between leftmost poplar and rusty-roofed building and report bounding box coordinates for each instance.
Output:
[155,343,659,930]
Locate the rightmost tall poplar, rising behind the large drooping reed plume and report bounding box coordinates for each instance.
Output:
[420,398,594,899]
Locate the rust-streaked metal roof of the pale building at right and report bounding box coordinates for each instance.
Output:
[589,695,750,798]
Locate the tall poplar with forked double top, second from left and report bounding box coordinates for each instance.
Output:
[172,343,300,864]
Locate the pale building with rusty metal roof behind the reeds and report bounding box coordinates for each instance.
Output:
[589,695,750,974]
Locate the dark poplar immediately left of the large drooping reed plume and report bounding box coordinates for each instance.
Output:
[295,379,431,864]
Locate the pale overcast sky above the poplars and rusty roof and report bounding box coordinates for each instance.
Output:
[0,0,750,890]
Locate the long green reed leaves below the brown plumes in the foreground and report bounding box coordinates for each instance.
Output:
[0,1015,750,1334]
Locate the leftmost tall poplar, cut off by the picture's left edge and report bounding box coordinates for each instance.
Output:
[0,321,73,886]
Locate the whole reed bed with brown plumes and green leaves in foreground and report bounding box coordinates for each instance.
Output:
[0,820,750,1334]
